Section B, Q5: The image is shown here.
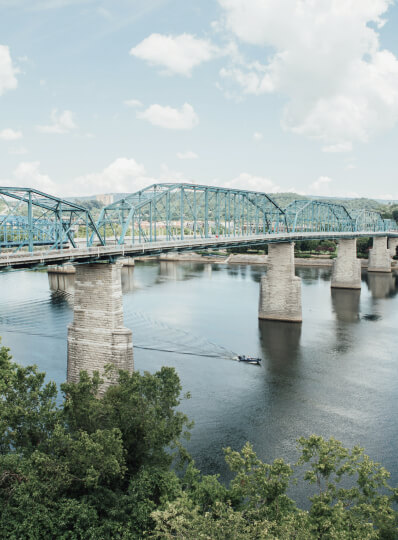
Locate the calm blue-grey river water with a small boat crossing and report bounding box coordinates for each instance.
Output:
[0,262,398,484]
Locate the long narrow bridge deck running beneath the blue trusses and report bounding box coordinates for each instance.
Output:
[0,231,398,270]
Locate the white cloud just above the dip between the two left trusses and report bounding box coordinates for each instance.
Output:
[69,157,152,195]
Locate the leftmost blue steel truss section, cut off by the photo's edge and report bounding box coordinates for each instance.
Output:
[0,187,104,251]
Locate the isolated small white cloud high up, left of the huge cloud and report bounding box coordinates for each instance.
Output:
[130,34,219,77]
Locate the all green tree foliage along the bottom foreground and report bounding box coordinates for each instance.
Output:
[0,340,398,540]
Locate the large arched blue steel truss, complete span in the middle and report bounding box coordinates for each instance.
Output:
[97,183,287,244]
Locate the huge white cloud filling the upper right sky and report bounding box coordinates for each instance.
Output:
[218,0,398,148]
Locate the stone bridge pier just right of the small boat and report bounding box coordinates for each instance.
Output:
[258,242,303,322]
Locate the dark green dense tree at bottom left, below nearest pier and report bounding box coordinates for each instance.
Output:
[0,340,188,539]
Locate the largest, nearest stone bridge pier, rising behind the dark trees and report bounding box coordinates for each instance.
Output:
[68,263,134,382]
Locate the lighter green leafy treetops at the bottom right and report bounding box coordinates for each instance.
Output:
[152,435,398,540]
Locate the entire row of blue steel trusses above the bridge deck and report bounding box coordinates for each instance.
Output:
[0,183,398,251]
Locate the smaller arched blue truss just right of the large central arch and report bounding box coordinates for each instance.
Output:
[285,199,354,232]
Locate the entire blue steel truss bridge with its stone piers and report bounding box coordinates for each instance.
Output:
[0,183,398,380]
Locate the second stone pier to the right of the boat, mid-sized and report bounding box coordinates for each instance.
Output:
[331,238,361,289]
